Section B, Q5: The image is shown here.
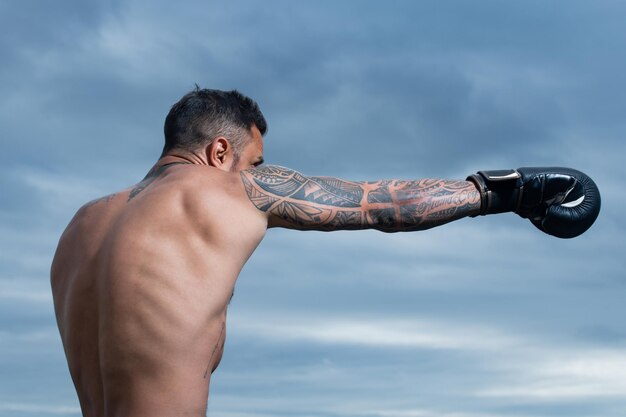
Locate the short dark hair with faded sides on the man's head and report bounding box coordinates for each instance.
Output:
[163,85,267,158]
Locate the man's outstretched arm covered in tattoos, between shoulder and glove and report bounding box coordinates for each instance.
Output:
[241,166,480,232]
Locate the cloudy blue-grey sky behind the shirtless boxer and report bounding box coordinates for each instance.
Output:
[0,0,626,417]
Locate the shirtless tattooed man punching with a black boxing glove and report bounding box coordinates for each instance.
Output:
[51,88,599,417]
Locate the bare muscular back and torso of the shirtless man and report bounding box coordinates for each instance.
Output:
[51,165,267,417]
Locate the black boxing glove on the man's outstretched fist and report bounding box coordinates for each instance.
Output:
[467,168,600,239]
